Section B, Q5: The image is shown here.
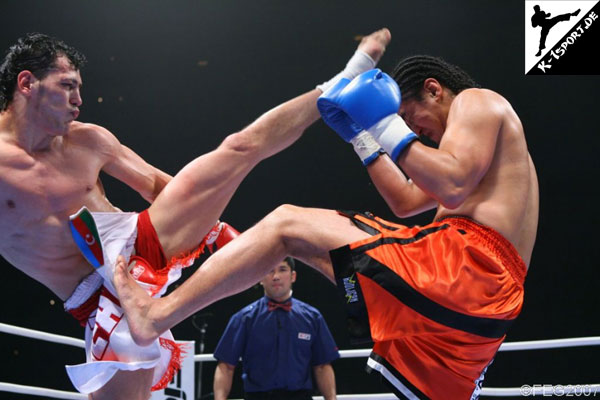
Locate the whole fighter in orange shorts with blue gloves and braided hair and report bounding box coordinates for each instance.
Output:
[115,56,539,400]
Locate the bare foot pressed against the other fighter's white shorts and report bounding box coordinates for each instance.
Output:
[114,256,162,346]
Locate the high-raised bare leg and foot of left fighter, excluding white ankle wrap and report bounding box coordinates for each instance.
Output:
[144,29,391,258]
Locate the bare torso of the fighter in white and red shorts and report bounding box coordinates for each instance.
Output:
[0,122,116,300]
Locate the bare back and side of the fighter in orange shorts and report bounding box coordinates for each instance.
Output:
[436,89,539,266]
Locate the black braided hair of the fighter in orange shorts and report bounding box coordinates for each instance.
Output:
[392,55,481,100]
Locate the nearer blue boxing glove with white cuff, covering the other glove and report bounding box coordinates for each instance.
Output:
[336,69,418,161]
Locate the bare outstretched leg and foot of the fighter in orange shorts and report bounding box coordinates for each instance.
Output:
[115,205,369,345]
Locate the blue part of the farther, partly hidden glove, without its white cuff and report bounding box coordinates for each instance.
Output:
[317,78,363,143]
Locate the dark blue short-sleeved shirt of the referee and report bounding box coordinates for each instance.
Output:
[214,296,340,392]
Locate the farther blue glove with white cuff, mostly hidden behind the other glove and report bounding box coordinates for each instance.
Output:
[317,78,381,166]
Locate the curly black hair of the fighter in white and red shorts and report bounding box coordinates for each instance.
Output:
[0,33,86,111]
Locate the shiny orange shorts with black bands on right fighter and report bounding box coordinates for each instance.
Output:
[330,212,526,399]
